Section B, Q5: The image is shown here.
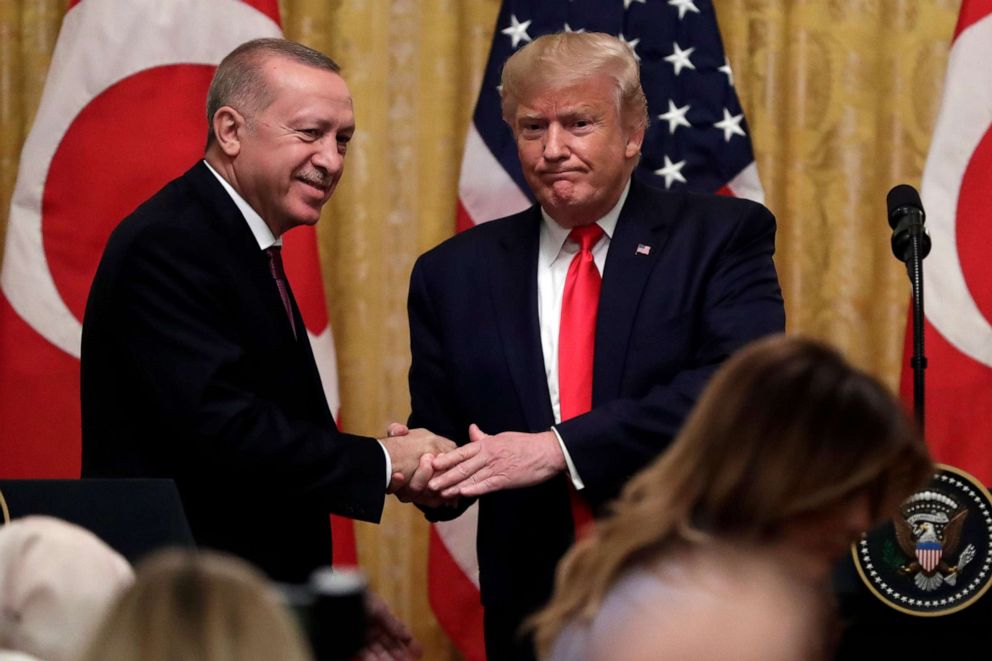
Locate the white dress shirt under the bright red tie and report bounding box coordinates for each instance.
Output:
[537,180,630,489]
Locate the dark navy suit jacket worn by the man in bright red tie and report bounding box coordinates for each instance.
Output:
[409,175,785,619]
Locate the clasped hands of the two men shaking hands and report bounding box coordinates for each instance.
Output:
[379,422,566,507]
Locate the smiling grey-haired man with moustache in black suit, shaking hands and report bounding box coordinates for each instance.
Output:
[82,39,454,604]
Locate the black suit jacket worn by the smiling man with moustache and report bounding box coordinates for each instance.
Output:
[82,162,386,581]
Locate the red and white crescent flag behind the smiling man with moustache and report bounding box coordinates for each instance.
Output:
[0,0,355,564]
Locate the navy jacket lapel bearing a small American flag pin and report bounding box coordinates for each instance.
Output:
[592,177,677,406]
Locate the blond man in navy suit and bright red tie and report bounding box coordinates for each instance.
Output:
[402,33,784,661]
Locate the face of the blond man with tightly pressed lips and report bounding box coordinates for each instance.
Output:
[512,75,644,228]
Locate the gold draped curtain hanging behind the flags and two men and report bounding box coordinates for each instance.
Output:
[0,0,960,661]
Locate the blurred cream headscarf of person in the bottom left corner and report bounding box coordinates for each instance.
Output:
[0,516,134,661]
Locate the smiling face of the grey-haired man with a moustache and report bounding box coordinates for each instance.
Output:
[215,55,355,236]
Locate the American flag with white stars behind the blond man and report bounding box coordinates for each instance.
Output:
[429,0,764,660]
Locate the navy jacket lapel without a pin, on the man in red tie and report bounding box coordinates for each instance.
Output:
[489,207,554,430]
